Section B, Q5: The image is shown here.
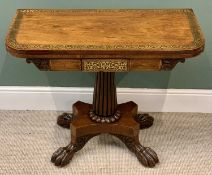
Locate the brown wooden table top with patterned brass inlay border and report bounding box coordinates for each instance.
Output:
[6,9,205,59]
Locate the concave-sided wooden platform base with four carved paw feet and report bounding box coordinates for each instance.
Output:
[51,101,159,167]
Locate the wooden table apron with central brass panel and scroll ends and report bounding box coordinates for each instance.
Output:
[27,58,185,72]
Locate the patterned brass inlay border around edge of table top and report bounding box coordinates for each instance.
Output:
[7,9,204,50]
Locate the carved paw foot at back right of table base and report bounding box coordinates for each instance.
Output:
[135,114,154,129]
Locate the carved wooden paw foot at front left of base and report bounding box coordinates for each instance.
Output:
[51,144,75,167]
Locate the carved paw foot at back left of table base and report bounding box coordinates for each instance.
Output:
[57,113,73,129]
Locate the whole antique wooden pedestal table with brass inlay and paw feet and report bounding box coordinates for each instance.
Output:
[6,9,204,167]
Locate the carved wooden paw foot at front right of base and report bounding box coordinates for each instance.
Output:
[134,144,159,167]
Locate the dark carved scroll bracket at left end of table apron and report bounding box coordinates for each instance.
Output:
[26,58,50,71]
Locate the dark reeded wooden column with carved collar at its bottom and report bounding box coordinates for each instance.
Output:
[90,72,121,123]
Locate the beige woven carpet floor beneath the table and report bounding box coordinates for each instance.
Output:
[0,111,212,175]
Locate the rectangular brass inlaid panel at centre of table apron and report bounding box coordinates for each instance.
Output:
[82,59,128,72]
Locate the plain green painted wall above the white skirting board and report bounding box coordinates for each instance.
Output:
[0,0,212,89]
